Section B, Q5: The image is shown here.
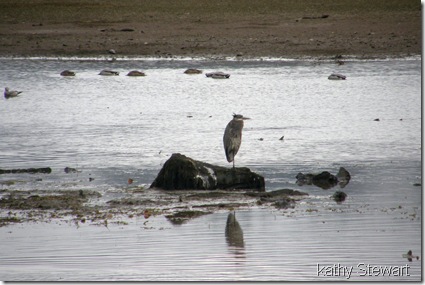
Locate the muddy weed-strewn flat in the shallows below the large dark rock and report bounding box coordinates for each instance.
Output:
[0,187,308,227]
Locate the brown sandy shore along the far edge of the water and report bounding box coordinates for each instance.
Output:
[0,0,421,58]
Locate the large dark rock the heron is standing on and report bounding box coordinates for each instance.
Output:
[150,153,265,191]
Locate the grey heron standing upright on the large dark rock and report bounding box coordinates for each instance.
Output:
[223,114,249,168]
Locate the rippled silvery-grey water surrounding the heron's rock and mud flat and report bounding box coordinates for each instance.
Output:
[0,59,422,281]
